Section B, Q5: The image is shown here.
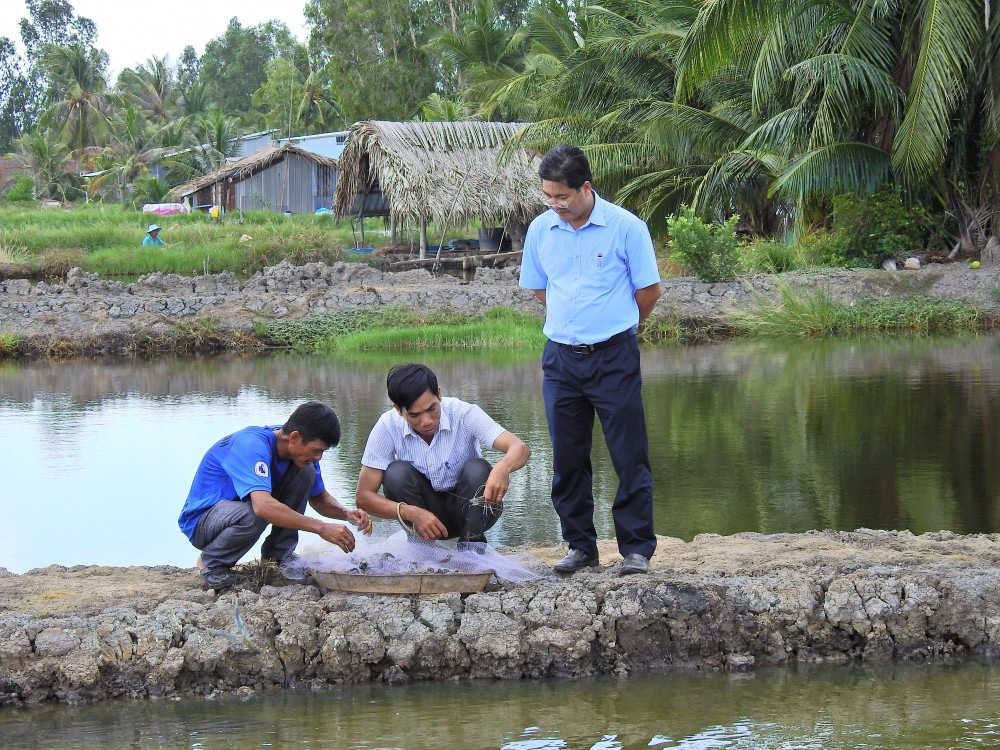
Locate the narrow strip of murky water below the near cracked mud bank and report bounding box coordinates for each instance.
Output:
[0,663,1000,750]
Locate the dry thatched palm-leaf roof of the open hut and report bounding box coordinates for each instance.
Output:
[333,120,545,226]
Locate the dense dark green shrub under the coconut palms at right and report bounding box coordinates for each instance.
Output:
[823,188,930,267]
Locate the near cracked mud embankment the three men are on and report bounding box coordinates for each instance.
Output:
[0,530,1000,706]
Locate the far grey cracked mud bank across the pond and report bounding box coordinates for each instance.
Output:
[0,262,1000,354]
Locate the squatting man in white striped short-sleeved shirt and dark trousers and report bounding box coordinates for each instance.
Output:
[354,364,531,542]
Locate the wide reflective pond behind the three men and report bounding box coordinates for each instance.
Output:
[0,336,1000,572]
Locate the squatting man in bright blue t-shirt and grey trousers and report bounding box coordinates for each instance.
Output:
[178,401,371,591]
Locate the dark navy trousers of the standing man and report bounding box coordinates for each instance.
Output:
[542,336,656,557]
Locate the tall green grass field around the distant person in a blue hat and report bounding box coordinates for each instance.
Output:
[0,204,480,276]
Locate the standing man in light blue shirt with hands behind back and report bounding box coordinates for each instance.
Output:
[520,146,661,575]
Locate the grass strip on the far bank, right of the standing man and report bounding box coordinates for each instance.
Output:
[727,285,986,338]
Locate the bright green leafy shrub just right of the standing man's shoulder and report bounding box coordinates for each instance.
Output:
[667,206,740,281]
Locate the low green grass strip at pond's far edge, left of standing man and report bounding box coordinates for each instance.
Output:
[257,307,545,352]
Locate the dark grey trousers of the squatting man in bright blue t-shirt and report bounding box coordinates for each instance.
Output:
[191,463,316,570]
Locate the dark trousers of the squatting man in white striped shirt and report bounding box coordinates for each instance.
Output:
[382,458,503,542]
